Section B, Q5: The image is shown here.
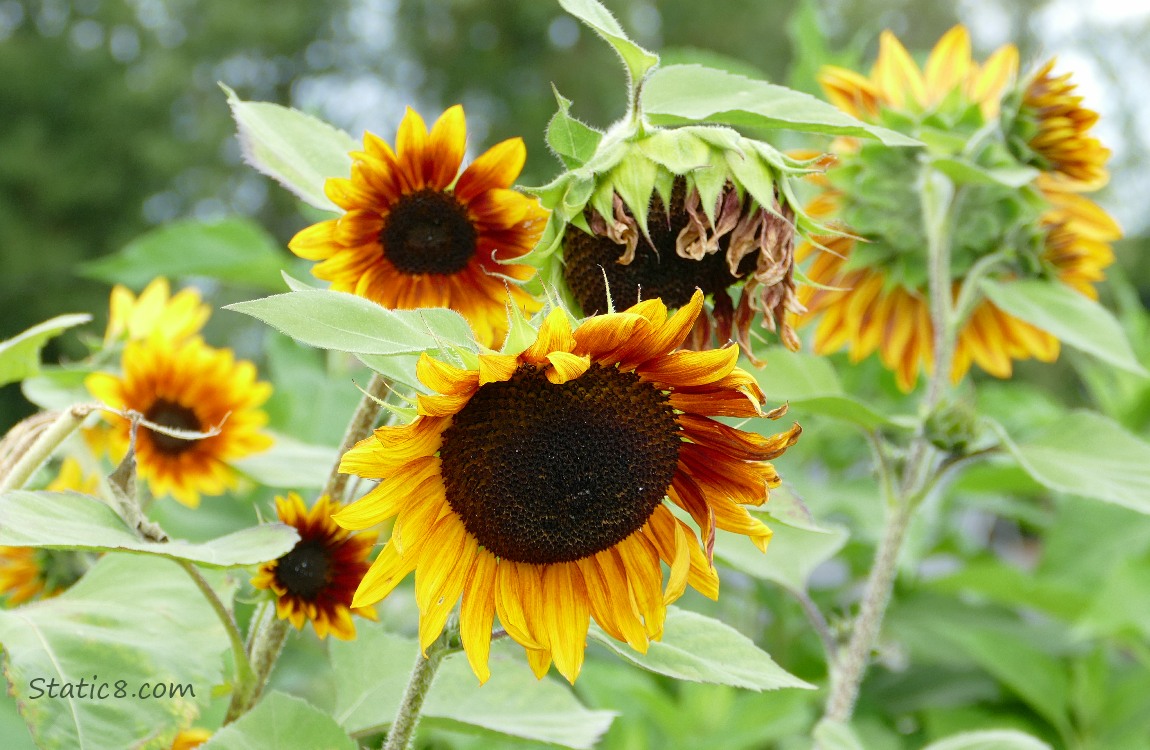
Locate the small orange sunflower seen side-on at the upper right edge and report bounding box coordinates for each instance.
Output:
[1019,60,1110,192]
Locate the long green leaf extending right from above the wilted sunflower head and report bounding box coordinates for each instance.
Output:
[642,66,919,146]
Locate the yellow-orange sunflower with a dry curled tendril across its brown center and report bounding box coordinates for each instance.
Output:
[85,336,271,507]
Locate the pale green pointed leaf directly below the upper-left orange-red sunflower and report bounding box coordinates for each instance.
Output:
[224,290,475,354]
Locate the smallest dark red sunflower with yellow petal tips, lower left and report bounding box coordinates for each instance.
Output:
[252,492,377,641]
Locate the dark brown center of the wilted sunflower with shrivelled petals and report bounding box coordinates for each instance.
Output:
[564,179,758,315]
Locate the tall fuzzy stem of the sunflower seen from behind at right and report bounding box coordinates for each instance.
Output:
[825,163,958,722]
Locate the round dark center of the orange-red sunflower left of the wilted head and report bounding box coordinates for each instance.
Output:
[380,190,478,275]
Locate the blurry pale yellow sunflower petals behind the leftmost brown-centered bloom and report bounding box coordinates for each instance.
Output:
[104,277,212,344]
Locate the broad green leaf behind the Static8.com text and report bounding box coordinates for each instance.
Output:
[0,554,232,750]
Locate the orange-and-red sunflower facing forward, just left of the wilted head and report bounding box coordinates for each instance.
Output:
[289,105,547,346]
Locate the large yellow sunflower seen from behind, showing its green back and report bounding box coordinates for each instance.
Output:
[796,26,1119,391]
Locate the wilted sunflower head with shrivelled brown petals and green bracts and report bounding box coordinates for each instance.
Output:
[531,100,826,358]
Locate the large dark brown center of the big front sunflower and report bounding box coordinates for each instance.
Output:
[440,365,680,565]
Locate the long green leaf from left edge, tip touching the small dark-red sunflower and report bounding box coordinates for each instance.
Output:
[0,490,299,567]
